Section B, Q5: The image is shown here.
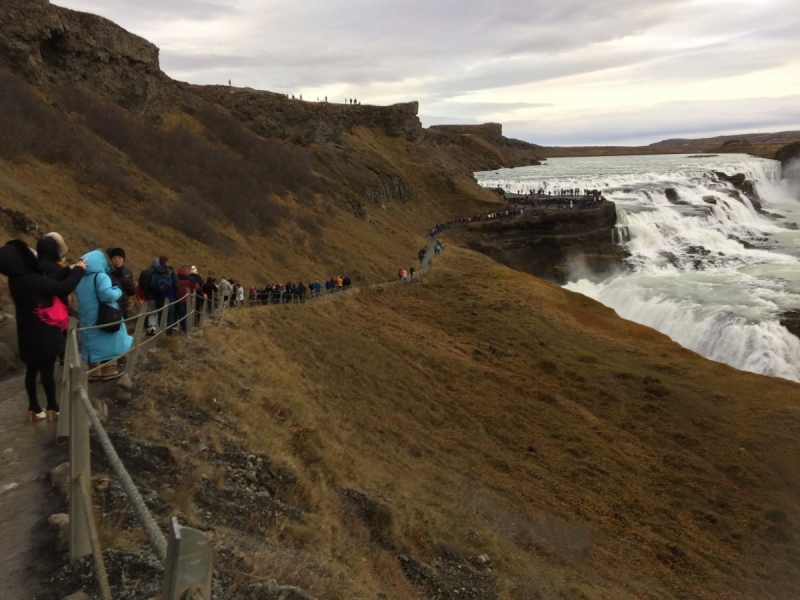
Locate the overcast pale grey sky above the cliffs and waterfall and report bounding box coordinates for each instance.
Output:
[55,0,800,145]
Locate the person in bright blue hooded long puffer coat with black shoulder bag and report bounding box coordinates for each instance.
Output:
[75,250,133,380]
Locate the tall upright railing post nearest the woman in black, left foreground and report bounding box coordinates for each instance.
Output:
[69,364,92,560]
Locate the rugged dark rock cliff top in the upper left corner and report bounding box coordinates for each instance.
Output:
[0,0,169,112]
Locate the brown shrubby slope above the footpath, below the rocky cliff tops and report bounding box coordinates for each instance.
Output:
[0,65,497,284]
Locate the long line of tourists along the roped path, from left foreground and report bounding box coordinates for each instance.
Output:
[0,232,353,421]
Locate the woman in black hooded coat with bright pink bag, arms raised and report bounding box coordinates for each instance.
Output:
[0,240,85,421]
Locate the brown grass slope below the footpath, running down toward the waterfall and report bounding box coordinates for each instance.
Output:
[122,249,800,599]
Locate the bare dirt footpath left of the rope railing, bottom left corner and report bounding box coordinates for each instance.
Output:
[0,369,67,600]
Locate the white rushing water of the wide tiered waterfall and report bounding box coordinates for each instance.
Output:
[475,154,800,381]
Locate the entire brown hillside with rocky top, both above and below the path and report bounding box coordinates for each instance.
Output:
[0,0,800,600]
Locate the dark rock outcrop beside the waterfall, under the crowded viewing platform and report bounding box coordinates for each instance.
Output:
[453,201,624,284]
